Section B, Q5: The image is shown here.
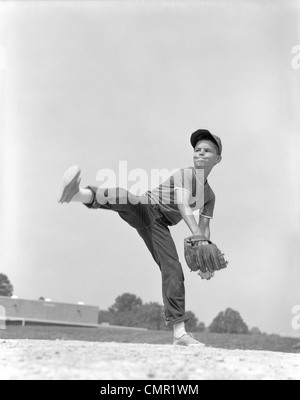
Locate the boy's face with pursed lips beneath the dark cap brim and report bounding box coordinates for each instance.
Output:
[194,140,222,171]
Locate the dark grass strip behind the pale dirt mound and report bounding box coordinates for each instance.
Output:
[0,325,300,354]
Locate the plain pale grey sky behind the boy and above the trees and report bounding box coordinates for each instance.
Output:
[0,0,300,337]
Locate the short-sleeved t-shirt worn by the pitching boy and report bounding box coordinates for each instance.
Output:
[147,167,216,225]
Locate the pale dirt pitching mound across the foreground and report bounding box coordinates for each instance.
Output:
[0,340,300,380]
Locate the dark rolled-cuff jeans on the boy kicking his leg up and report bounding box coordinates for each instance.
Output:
[85,186,188,326]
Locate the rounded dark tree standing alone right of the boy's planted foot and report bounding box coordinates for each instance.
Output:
[209,308,249,334]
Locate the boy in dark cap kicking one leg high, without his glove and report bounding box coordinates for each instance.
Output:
[58,129,222,346]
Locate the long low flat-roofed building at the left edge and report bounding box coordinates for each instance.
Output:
[0,296,99,327]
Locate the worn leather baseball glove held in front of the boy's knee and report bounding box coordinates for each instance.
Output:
[184,236,228,280]
